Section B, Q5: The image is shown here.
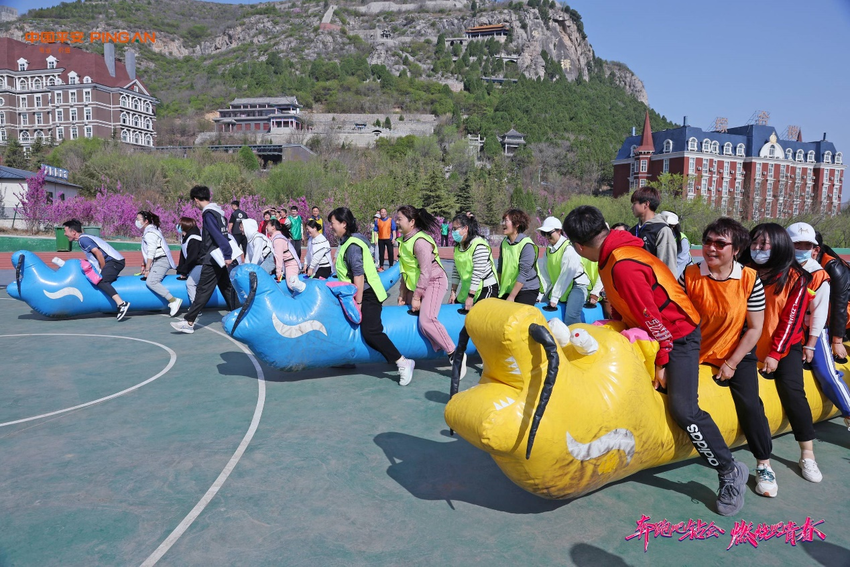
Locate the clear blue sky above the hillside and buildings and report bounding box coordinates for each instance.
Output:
[6,0,850,197]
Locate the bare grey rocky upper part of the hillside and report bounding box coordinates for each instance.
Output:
[0,0,647,104]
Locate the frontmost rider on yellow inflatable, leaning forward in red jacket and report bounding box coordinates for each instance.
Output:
[563,205,750,516]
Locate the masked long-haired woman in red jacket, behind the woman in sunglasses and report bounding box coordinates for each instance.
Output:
[742,223,823,482]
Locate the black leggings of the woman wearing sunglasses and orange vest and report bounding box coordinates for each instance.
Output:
[728,349,773,461]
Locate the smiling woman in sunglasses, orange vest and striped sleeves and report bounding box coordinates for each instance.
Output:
[679,217,778,497]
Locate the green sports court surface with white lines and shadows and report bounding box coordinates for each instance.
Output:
[0,290,850,567]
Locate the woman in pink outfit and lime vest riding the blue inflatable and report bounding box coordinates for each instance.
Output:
[396,205,466,374]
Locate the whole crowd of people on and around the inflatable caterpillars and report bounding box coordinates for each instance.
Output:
[65,186,850,515]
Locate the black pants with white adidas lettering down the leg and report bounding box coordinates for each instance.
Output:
[667,327,733,473]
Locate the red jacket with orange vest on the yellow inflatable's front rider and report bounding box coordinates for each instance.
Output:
[599,230,699,366]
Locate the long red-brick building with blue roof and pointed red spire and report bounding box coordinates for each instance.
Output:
[613,113,845,220]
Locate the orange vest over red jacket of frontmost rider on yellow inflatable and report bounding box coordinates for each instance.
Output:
[599,246,699,328]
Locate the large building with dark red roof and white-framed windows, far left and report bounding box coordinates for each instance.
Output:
[0,38,157,147]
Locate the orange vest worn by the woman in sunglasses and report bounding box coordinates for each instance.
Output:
[684,264,758,366]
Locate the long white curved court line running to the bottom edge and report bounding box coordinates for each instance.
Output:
[141,327,266,567]
